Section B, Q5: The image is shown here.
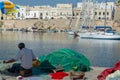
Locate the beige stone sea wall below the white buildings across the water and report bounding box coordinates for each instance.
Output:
[0,19,120,32]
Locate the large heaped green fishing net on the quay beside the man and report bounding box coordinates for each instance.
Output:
[33,49,90,74]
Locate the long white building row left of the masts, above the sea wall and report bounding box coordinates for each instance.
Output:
[16,4,72,19]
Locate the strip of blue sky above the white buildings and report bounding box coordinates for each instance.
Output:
[10,0,116,7]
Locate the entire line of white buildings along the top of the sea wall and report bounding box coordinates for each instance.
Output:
[13,2,115,20]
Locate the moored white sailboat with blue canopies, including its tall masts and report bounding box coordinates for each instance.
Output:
[75,0,120,40]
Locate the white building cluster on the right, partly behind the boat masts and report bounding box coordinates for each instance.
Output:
[77,2,115,20]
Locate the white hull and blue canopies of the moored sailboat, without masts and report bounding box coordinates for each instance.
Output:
[77,26,120,40]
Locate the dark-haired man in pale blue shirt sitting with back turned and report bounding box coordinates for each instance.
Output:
[3,43,37,76]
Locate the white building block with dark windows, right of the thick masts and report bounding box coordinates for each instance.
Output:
[95,2,115,20]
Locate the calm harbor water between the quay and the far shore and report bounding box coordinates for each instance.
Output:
[0,31,120,67]
